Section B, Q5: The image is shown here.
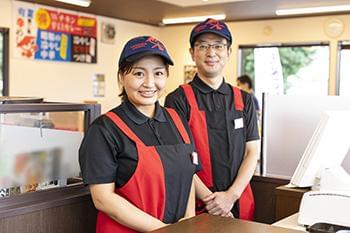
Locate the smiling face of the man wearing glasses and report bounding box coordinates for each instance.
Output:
[190,33,232,78]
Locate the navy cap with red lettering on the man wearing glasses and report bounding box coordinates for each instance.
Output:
[190,18,232,47]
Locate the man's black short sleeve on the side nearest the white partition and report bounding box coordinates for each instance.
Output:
[241,91,259,142]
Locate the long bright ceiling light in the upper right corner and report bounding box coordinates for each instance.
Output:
[276,5,350,15]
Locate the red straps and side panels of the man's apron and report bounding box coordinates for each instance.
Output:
[181,84,255,220]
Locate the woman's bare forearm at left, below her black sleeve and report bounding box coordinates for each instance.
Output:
[89,183,166,232]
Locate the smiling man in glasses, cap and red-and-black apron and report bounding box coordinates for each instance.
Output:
[165,19,259,219]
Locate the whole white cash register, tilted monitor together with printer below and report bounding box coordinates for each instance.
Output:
[291,110,350,227]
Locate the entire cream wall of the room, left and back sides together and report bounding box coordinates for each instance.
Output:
[0,0,350,111]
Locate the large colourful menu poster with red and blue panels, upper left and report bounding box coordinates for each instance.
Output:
[13,1,97,63]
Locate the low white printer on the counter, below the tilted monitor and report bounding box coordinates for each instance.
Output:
[298,167,350,227]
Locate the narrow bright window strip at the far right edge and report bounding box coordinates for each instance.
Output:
[337,41,350,96]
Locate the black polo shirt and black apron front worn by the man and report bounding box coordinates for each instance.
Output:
[165,75,259,191]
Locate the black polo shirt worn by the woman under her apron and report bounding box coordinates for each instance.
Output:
[79,100,193,187]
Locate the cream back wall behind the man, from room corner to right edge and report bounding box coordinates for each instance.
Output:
[160,15,350,94]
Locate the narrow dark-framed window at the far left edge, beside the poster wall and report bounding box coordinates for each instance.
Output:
[0,27,9,96]
